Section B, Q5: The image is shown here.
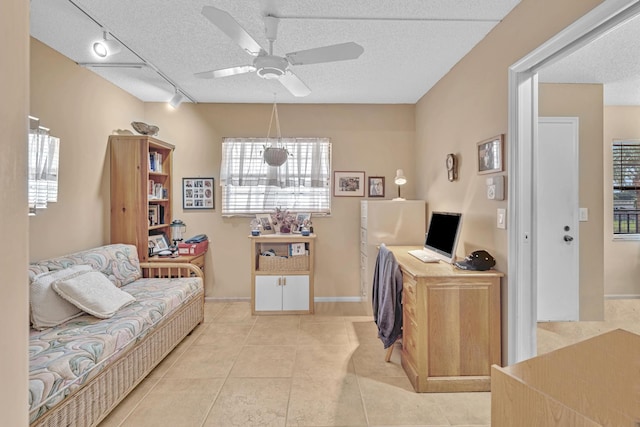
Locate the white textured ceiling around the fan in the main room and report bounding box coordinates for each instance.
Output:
[31,0,519,103]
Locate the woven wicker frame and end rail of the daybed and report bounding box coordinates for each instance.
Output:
[31,262,204,427]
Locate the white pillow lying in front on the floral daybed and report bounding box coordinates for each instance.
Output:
[51,270,136,319]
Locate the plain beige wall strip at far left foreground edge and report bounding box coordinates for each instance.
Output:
[0,0,29,426]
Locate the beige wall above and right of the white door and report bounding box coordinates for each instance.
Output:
[538,84,604,320]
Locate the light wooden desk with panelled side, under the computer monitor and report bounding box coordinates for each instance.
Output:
[388,246,504,392]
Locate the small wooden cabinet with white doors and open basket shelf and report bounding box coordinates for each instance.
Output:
[249,234,316,314]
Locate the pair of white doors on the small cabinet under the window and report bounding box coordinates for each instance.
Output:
[255,275,309,311]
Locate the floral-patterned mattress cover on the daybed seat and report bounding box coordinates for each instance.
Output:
[29,277,202,422]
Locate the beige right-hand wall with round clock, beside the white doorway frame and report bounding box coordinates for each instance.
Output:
[416,0,601,342]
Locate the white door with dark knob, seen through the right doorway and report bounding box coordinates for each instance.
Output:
[534,117,580,321]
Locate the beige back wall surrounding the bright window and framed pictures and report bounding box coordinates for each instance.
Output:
[145,104,415,298]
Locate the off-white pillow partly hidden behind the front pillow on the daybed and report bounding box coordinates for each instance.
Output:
[29,265,91,329]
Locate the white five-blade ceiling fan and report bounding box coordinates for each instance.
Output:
[195,6,364,97]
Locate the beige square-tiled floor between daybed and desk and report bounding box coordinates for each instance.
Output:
[100,300,640,427]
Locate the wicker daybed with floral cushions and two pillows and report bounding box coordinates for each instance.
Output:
[29,244,204,427]
